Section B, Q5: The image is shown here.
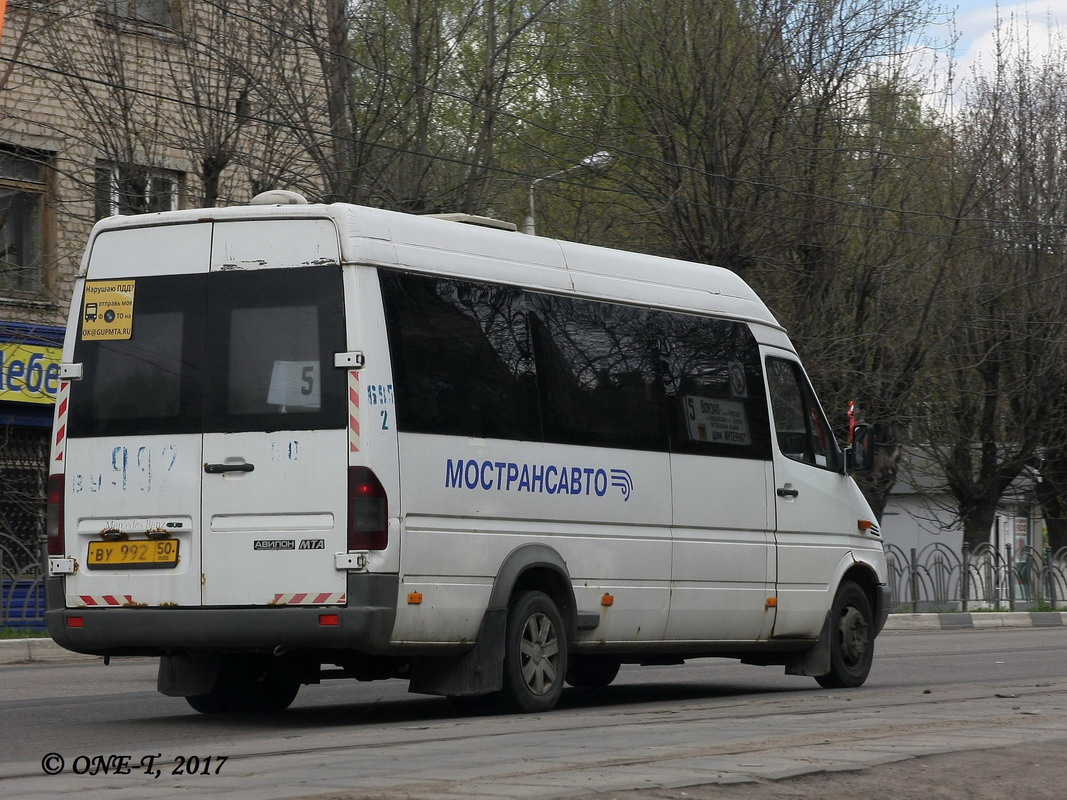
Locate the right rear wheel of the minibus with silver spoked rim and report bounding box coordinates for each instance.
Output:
[501,592,568,713]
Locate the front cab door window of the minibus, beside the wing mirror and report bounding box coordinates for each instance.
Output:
[767,358,839,469]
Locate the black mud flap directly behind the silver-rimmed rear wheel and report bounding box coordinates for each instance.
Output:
[408,608,507,698]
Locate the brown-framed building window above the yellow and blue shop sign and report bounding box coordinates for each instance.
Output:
[0,150,46,293]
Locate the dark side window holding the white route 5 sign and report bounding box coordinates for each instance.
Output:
[659,313,770,459]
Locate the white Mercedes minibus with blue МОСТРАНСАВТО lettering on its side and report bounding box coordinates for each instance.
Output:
[47,192,889,713]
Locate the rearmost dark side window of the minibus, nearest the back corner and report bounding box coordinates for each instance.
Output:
[379,271,541,441]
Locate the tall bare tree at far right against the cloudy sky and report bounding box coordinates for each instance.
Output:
[917,27,1067,546]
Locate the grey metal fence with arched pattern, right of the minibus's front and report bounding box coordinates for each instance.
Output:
[886,544,1067,612]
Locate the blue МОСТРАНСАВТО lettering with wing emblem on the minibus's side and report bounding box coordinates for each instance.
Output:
[445,459,634,502]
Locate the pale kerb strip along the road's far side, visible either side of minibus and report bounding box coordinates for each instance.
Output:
[0,611,1067,666]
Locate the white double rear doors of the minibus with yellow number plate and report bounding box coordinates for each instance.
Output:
[64,220,347,606]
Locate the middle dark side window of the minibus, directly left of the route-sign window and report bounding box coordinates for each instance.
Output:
[529,294,668,450]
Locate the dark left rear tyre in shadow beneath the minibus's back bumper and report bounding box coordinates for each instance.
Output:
[186,658,300,714]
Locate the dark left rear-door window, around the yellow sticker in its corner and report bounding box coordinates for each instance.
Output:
[69,275,207,436]
